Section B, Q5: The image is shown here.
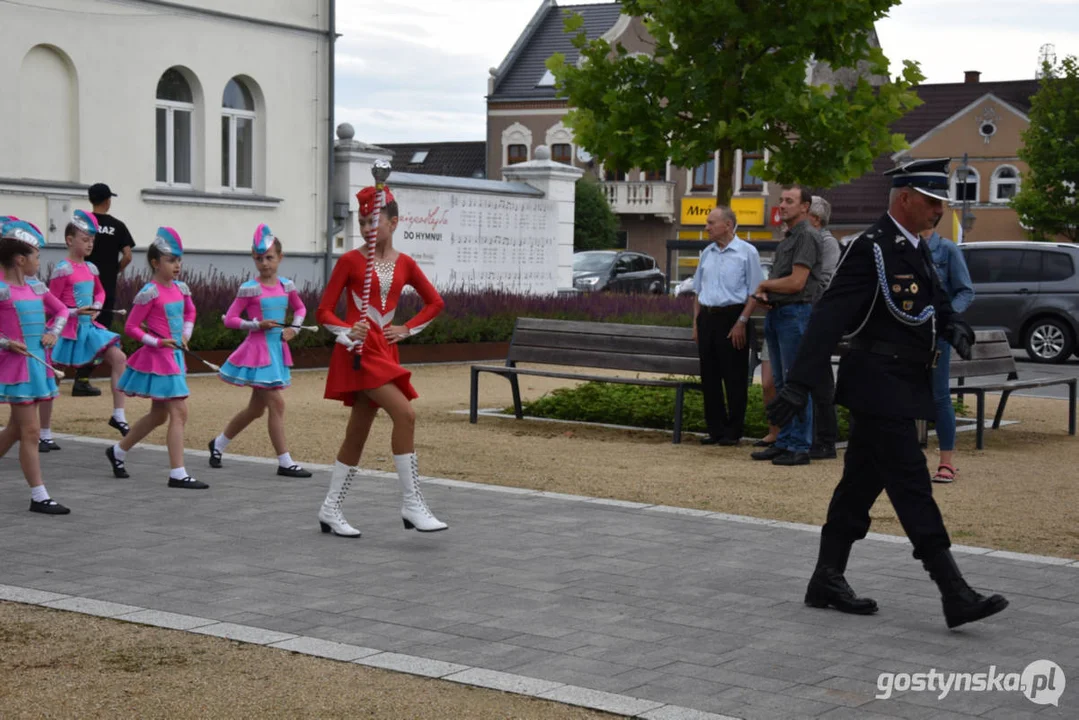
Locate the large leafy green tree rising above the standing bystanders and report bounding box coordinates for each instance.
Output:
[547,0,923,202]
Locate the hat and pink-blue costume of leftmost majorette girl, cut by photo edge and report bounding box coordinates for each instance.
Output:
[0,218,68,405]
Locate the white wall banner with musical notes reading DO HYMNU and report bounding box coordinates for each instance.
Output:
[391,189,558,295]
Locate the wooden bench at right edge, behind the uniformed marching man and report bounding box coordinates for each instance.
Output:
[932,329,1077,450]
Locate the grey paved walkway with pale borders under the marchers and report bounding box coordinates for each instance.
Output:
[0,438,1079,720]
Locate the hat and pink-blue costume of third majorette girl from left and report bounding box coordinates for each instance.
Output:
[117,228,195,400]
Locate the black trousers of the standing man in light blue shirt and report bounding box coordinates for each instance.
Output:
[697,304,753,439]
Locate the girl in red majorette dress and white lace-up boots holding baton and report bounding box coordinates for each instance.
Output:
[317,186,448,538]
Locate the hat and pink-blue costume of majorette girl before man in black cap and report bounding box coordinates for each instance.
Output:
[49,210,120,367]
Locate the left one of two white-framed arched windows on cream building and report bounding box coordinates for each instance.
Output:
[155,68,195,187]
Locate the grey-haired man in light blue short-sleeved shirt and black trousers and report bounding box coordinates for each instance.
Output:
[693,205,764,446]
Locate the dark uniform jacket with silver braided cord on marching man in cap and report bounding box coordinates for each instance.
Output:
[787,215,952,420]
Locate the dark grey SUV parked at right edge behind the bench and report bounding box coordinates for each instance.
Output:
[960,242,1079,363]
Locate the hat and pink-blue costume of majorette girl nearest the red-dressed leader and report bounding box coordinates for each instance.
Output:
[219,225,308,390]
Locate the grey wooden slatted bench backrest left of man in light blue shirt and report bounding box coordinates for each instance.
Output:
[506,317,700,377]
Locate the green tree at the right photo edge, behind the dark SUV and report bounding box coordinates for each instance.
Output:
[1011,56,1079,243]
